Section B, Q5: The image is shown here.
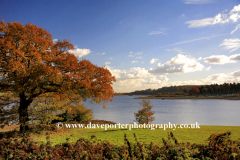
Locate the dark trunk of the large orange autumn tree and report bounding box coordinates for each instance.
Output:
[18,94,32,132]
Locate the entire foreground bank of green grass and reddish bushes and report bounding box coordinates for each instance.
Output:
[0,125,240,159]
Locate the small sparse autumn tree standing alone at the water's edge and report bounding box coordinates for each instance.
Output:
[134,100,155,124]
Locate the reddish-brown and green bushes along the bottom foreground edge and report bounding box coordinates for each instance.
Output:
[0,132,240,160]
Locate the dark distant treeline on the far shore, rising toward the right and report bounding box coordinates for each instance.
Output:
[115,82,240,95]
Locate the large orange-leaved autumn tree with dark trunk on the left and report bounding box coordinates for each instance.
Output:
[0,21,116,131]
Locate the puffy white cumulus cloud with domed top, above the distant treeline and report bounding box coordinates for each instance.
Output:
[149,54,204,75]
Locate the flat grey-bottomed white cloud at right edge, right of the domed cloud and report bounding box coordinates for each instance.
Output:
[204,54,240,64]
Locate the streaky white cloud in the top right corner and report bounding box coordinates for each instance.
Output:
[186,4,240,28]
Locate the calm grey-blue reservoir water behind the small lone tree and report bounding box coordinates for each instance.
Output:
[83,96,240,126]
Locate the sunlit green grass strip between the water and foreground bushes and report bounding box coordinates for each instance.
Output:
[26,126,240,146]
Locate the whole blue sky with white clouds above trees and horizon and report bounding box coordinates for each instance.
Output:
[0,0,240,92]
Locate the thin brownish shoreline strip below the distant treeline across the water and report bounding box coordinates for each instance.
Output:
[134,96,240,100]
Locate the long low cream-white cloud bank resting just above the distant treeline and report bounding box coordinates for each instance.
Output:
[106,66,240,92]
